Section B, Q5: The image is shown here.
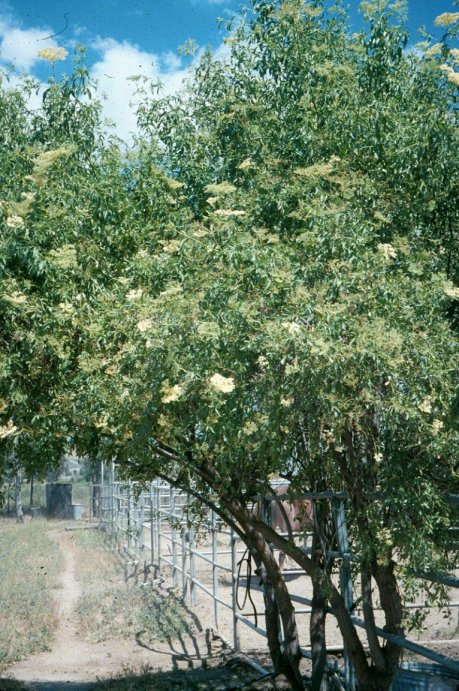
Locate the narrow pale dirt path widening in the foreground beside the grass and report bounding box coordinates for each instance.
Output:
[8,528,216,691]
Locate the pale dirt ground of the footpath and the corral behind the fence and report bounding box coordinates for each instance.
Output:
[0,523,459,691]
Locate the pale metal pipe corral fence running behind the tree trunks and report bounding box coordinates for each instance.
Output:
[96,465,459,691]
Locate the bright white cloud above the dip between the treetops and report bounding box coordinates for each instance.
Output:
[91,38,187,141]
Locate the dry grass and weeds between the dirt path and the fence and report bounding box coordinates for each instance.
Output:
[74,530,193,642]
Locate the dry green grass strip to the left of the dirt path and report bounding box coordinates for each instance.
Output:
[0,519,62,672]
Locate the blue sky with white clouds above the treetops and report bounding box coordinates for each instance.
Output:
[0,0,458,141]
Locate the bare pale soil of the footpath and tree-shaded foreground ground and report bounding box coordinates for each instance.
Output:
[0,524,257,691]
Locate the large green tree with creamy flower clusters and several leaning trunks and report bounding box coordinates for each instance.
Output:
[2,0,459,689]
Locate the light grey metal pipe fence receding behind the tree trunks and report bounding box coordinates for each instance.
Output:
[96,474,459,691]
